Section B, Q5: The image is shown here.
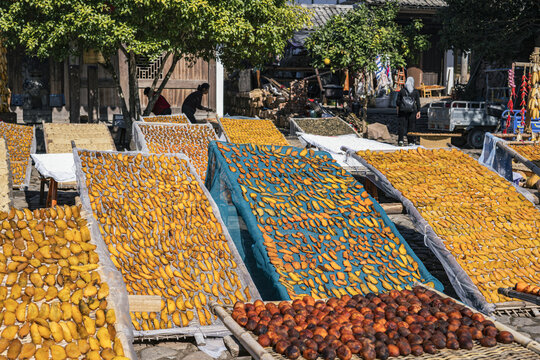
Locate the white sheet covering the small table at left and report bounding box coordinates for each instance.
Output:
[31,153,77,183]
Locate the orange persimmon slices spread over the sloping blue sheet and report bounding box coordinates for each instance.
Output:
[213,142,433,298]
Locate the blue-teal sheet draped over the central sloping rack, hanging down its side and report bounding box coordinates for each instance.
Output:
[206,142,442,300]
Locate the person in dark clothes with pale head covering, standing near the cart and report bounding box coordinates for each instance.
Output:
[396,76,420,146]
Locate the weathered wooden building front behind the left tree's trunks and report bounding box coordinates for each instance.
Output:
[7,49,223,123]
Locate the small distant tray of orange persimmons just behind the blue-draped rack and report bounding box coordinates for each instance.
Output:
[220,118,289,146]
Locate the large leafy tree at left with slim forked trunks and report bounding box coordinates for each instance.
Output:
[0,0,309,145]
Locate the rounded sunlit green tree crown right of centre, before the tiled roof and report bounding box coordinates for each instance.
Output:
[306,1,429,71]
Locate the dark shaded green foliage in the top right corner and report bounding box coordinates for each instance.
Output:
[441,0,540,63]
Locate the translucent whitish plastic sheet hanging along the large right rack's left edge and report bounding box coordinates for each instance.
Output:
[347,150,540,313]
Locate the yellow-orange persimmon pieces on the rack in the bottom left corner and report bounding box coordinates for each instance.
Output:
[0,206,127,360]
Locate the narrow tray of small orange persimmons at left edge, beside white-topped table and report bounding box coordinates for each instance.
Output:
[0,121,34,186]
